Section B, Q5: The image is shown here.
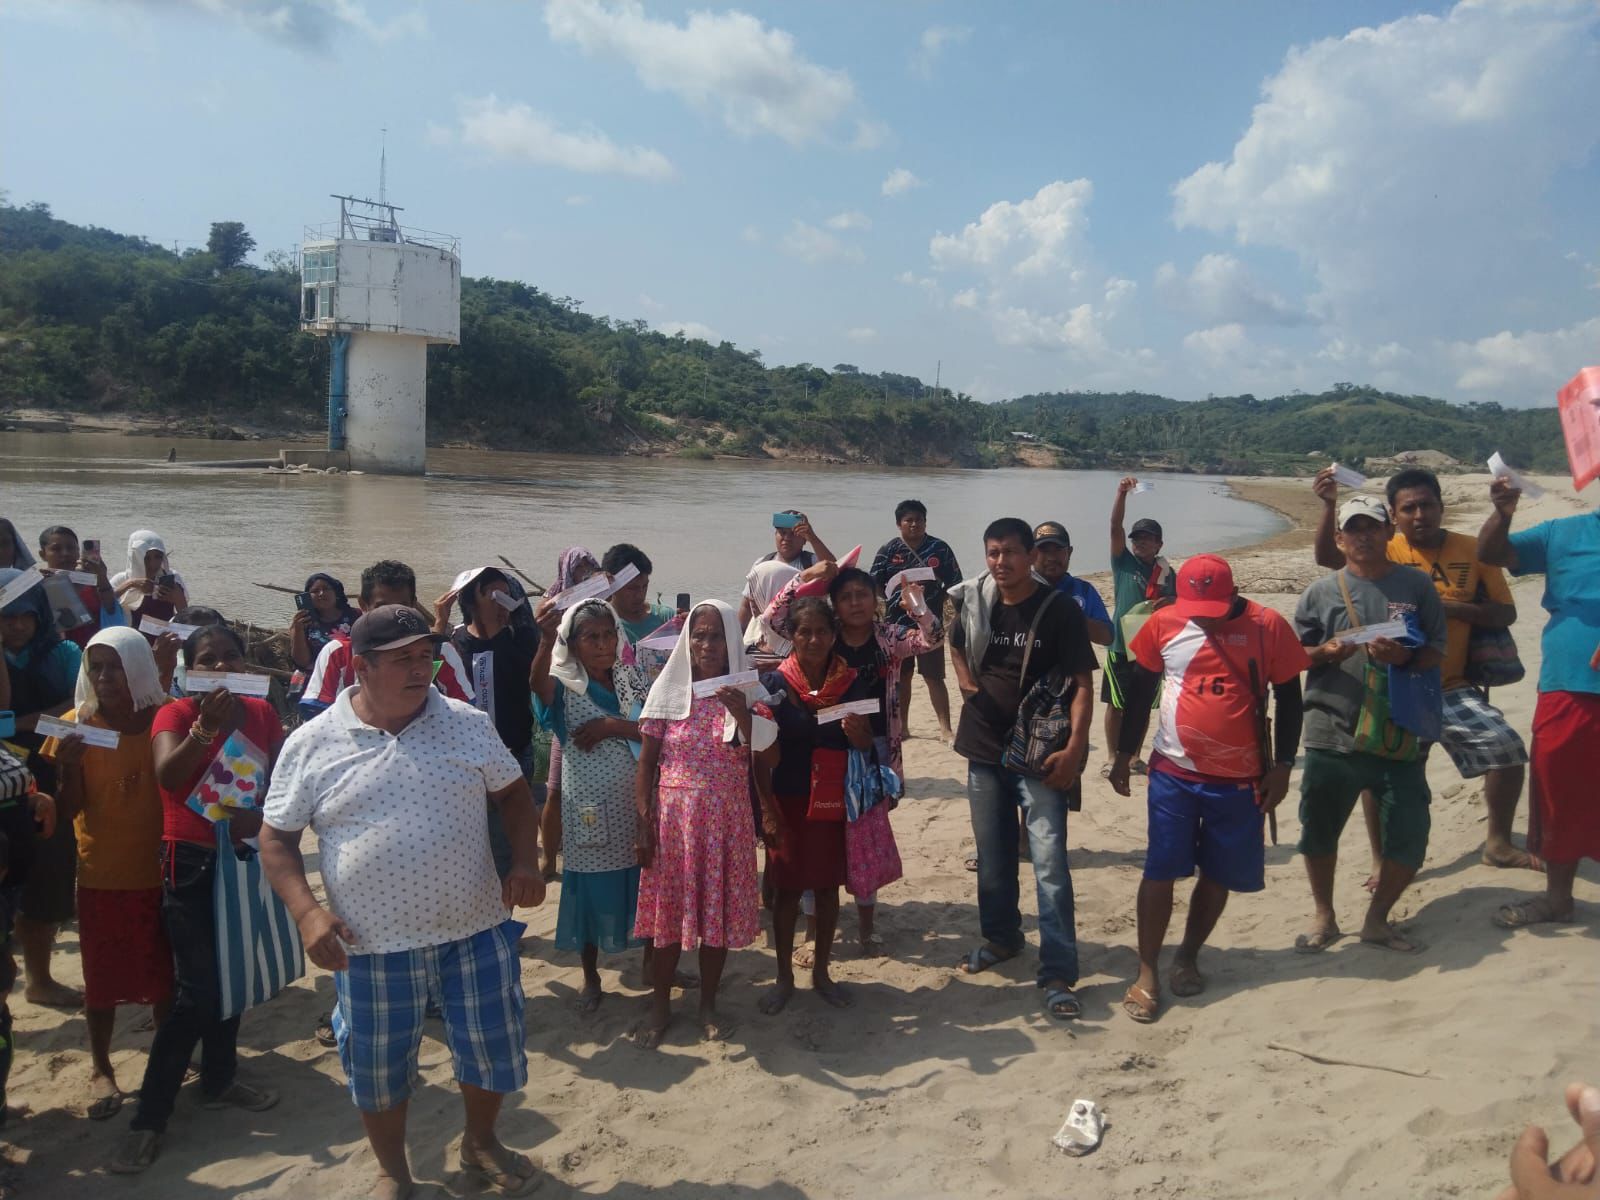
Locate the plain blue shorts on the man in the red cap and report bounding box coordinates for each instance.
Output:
[1144,770,1267,891]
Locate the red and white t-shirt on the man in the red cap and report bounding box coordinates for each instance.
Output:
[1128,600,1310,779]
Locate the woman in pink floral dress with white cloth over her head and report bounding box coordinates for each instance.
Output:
[634,600,778,1048]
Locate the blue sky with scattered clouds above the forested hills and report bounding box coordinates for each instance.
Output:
[0,0,1600,406]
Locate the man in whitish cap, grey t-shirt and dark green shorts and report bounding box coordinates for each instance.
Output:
[1294,496,1445,954]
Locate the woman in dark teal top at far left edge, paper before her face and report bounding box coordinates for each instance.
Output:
[0,568,83,1008]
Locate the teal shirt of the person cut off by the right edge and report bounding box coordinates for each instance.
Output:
[1510,512,1600,694]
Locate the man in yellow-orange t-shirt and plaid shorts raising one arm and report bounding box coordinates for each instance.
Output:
[1312,467,1542,870]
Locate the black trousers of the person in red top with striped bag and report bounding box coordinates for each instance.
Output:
[131,842,238,1133]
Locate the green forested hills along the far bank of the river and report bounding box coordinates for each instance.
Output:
[0,203,1563,472]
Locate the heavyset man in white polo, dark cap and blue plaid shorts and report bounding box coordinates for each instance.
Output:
[261,605,544,1200]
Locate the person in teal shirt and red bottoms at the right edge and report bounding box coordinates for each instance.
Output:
[1478,478,1600,928]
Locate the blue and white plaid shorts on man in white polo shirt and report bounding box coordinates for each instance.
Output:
[333,920,528,1112]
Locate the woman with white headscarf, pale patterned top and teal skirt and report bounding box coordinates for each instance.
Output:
[530,597,650,1013]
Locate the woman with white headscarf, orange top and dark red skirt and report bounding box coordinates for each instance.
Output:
[43,627,173,1120]
